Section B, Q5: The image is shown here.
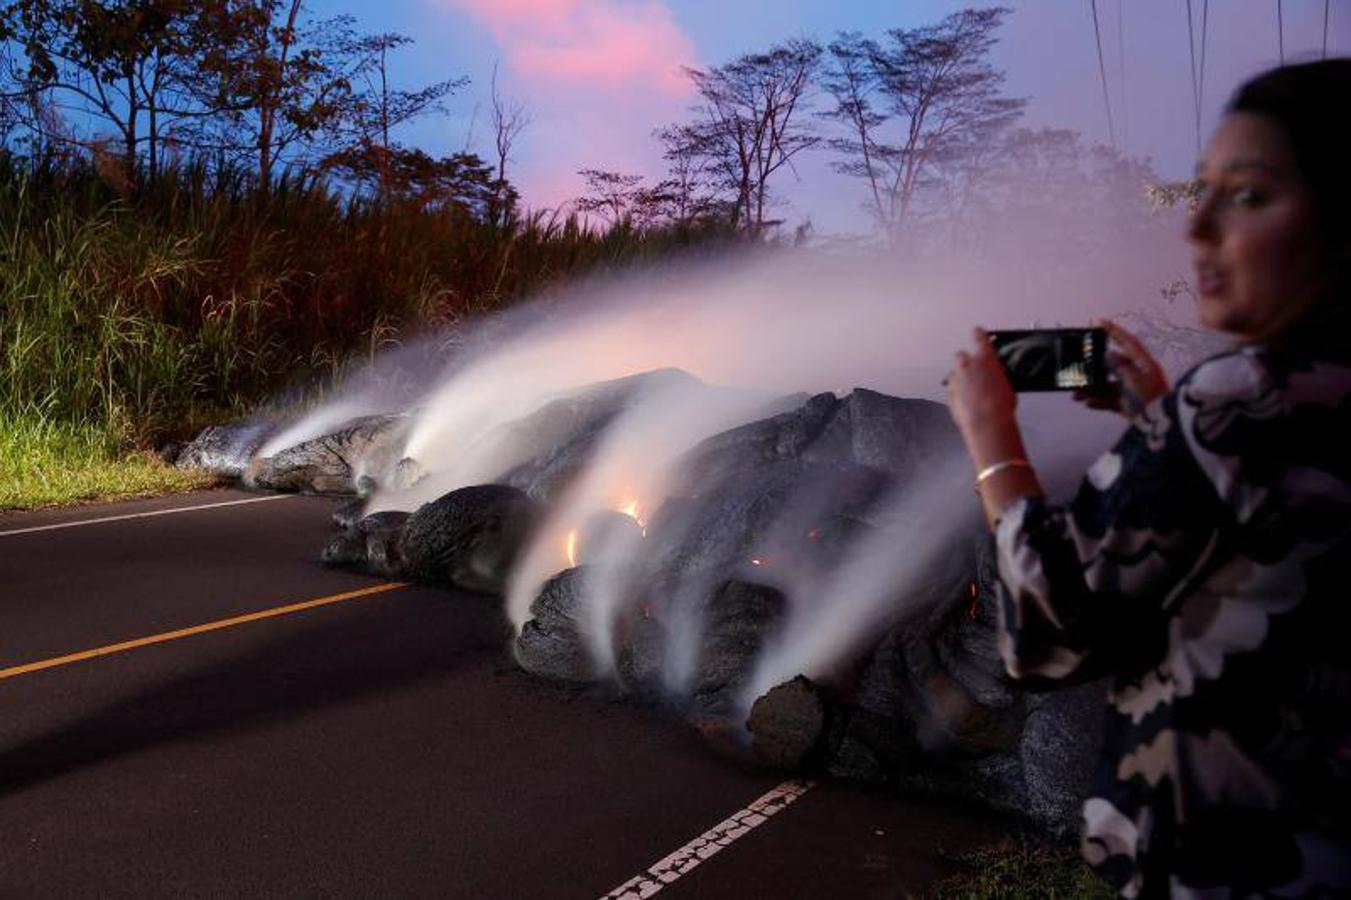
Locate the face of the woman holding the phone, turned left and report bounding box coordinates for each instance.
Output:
[1188,112,1327,339]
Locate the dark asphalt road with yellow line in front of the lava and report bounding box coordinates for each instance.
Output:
[0,491,997,900]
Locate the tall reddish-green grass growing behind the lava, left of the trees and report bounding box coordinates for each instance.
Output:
[0,153,723,508]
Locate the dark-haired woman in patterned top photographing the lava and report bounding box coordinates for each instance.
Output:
[948,59,1351,896]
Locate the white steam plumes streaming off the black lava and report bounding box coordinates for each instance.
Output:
[263,237,1194,697]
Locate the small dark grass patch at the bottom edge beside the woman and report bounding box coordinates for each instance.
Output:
[934,838,1116,900]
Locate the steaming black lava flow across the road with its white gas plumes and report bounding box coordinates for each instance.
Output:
[174,240,1221,827]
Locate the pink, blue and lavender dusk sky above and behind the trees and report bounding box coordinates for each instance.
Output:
[321,0,1351,232]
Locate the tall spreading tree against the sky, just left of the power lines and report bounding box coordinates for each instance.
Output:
[824,8,1024,243]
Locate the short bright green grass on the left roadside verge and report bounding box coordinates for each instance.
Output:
[0,419,215,511]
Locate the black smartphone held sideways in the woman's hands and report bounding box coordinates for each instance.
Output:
[989,328,1108,393]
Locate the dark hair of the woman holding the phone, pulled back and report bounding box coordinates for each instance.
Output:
[1228,58,1351,305]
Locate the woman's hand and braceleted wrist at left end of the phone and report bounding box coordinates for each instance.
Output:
[947,328,1042,526]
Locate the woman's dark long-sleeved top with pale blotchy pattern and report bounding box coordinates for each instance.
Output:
[996,341,1351,897]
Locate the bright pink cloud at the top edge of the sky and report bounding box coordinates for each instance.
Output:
[442,0,696,97]
